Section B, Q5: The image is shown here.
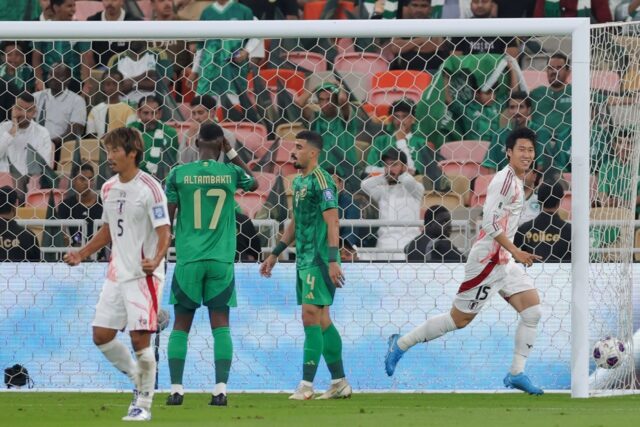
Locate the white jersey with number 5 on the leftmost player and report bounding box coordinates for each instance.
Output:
[101,171,169,283]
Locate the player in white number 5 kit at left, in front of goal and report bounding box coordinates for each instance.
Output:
[64,128,171,421]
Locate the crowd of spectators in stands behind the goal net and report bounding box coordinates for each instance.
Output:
[0,0,640,262]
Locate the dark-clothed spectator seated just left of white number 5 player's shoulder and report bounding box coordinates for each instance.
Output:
[56,163,102,246]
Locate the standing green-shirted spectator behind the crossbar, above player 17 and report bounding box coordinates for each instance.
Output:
[188,0,260,105]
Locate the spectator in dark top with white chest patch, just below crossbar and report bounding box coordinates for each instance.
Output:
[108,40,173,104]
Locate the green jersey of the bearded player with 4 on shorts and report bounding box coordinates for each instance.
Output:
[292,167,338,268]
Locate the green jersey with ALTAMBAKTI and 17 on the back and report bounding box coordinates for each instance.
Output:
[166,160,255,264]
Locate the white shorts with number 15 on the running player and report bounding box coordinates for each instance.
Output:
[453,259,535,313]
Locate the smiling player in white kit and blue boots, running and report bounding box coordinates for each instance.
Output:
[385,128,543,395]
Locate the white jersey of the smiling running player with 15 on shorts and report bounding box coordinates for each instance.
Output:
[467,166,524,264]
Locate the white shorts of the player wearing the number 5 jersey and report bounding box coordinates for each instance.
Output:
[92,276,164,331]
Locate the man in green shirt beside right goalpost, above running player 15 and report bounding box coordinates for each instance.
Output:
[529,52,571,138]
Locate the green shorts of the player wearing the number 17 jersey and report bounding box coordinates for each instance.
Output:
[170,260,237,310]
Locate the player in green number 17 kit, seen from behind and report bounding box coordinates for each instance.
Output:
[166,123,258,406]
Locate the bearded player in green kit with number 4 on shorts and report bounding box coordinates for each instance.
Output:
[260,131,351,400]
